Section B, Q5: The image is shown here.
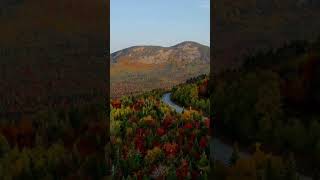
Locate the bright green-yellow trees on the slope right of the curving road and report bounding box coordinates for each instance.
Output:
[171,75,210,115]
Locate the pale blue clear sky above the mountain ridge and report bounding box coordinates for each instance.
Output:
[110,0,210,53]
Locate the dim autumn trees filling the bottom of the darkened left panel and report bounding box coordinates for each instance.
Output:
[0,102,109,179]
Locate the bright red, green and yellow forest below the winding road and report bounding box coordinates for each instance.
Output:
[110,90,210,180]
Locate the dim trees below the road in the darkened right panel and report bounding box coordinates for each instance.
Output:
[213,144,301,180]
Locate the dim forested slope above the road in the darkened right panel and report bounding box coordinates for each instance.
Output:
[211,37,320,172]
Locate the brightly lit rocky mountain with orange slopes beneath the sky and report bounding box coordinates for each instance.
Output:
[110,41,210,97]
